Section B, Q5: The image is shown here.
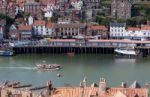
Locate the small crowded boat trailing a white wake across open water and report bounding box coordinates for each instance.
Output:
[36,64,60,70]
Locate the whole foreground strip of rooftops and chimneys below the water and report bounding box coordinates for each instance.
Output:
[0,77,150,97]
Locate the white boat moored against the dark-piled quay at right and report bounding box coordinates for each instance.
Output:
[114,47,140,57]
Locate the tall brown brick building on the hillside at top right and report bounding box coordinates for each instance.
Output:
[111,0,132,19]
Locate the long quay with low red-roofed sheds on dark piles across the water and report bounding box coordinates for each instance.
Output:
[10,39,150,55]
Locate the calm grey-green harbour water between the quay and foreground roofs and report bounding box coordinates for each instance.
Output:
[0,54,150,86]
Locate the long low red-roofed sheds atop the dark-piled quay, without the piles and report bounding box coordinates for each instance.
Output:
[10,39,150,48]
